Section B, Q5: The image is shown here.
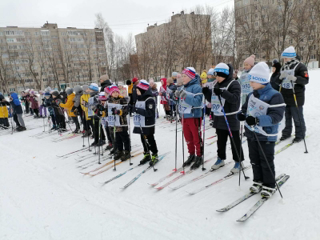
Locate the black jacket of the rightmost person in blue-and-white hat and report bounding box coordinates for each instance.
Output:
[275,60,309,106]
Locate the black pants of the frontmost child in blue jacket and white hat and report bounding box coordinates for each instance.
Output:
[248,139,275,188]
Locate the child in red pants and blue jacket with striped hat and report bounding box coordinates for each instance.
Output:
[175,67,203,169]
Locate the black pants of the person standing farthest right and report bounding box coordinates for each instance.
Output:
[282,105,306,139]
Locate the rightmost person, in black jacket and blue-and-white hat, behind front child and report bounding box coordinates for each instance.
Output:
[276,46,309,142]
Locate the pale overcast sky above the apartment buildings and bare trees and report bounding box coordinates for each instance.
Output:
[0,0,234,37]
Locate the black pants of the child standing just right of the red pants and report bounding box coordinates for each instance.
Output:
[216,129,244,162]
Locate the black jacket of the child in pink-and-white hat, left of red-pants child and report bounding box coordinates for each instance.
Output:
[133,88,156,135]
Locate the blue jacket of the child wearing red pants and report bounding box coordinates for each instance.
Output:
[183,78,203,118]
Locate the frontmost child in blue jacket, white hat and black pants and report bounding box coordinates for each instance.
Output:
[237,62,285,198]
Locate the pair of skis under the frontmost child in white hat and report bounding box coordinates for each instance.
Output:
[217,174,290,222]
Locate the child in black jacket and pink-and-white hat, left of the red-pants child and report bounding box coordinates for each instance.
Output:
[133,80,158,166]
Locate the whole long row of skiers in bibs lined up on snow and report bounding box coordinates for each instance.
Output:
[0,47,309,198]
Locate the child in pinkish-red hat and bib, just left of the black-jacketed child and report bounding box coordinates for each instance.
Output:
[106,85,130,161]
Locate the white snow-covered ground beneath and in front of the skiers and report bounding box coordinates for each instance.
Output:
[0,70,320,240]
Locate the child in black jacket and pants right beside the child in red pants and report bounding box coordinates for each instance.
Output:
[203,63,244,173]
